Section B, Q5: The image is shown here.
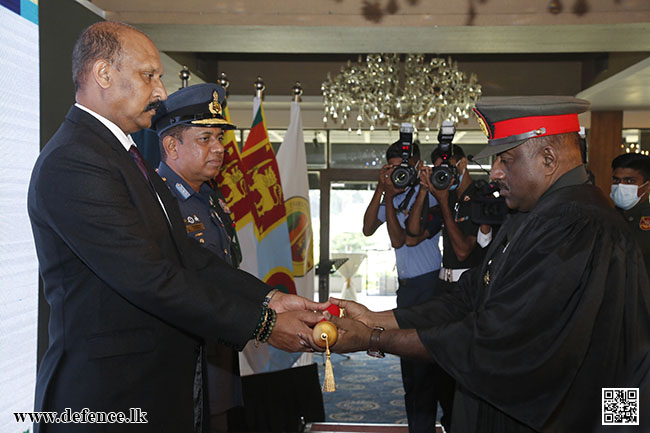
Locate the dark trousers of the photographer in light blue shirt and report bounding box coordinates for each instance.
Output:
[397,270,456,433]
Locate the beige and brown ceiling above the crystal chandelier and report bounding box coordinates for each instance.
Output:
[77,0,650,126]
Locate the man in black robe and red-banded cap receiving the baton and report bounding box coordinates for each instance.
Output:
[308,97,650,433]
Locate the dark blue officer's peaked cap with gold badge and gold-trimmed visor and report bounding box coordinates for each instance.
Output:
[151,83,236,135]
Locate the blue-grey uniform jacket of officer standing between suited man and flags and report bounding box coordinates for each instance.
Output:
[158,161,232,264]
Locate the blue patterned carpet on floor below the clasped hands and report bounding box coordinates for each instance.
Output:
[314,352,406,424]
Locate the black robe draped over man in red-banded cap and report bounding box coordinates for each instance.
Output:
[396,186,650,431]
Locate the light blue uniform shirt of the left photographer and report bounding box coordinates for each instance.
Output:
[377,185,442,279]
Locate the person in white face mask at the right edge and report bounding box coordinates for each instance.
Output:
[610,153,650,275]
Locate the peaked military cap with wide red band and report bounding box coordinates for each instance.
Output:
[474,96,589,159]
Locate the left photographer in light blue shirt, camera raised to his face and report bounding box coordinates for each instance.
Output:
[363,138,451,433]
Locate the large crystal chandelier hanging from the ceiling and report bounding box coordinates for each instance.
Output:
[321,54,481,134]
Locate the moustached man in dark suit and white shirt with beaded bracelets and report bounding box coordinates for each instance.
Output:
[28,22,323,433]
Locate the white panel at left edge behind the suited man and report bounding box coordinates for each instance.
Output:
[0,6,40,433]
